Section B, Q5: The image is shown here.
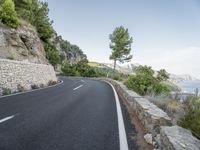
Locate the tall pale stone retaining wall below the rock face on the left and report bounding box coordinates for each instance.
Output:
[0,59,57,95]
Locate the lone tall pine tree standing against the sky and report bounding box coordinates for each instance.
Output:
[109,26,133,70]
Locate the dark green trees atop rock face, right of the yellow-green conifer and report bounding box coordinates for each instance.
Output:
[15,0,54,42]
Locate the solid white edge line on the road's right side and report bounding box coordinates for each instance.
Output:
[105,81,128,150]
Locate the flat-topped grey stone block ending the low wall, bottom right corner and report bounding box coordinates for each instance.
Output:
[160,126,200,150]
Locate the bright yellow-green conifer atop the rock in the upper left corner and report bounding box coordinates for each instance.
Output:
[0,0,19,29]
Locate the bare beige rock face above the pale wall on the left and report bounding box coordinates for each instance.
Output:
[0,25,48,64]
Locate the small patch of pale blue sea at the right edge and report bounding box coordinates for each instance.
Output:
[177,80,200,93]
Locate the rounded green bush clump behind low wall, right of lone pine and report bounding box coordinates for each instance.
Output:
[125,66,169,95]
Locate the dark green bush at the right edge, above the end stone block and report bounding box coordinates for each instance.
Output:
[179,97,200,139]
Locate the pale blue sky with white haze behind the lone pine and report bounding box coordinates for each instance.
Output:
[47,0,200,78]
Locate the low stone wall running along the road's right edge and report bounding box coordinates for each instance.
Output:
[101,79,200,150]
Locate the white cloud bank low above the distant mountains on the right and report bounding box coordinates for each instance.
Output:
[136,47,200,78]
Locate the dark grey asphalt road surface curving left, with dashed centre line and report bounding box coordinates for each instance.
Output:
[0,77,137,150]
